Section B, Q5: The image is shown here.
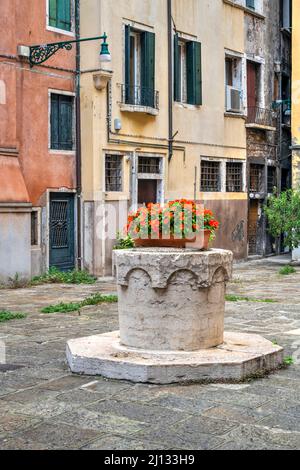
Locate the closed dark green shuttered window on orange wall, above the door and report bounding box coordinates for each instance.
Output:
[50,93,75,150]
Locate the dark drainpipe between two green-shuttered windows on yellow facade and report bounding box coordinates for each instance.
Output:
[167,0,174,162]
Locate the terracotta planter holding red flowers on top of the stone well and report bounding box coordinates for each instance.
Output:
[134,230,211,250]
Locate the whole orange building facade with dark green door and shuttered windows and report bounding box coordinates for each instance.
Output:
[0,0,77,282]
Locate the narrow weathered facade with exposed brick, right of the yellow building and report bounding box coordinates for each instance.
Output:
[245,0,291,256]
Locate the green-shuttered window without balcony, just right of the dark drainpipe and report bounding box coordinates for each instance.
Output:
[174,34,202,105]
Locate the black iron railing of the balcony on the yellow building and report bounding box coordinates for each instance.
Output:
[122,85,159,109]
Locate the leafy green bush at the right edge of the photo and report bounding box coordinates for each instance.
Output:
[265,189,300,249]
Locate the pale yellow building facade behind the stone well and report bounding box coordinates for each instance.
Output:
[80,0,248,275]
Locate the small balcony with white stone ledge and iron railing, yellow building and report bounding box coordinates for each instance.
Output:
[120,85,159,116]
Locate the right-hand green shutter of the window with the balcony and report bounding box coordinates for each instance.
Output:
[141,32,155,108]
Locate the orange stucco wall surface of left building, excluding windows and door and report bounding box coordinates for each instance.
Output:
[0,0,76,206]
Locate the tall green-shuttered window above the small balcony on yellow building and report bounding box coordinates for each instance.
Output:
[124,25,156,108]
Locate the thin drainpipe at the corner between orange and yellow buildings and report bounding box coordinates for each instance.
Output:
[75,0,82,270]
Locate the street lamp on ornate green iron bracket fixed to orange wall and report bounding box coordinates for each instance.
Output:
[26,33,111,67]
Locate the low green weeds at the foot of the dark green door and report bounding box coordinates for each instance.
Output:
[31,268,97,285]
